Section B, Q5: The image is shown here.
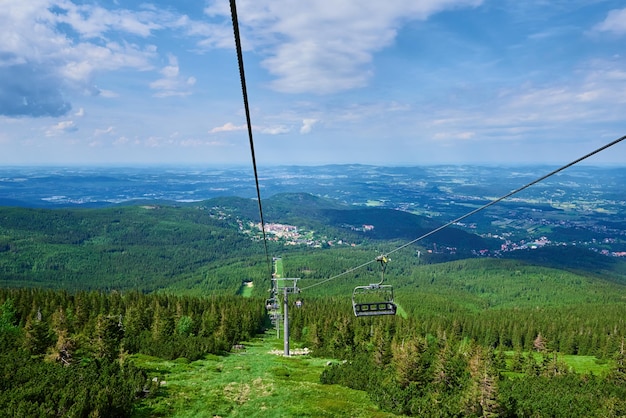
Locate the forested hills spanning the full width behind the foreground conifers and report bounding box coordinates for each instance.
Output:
[0,193,626,315]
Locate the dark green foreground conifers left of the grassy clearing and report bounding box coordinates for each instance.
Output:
[0,289,267,417]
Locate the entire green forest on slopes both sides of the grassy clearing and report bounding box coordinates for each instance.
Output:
[0,201,626,417]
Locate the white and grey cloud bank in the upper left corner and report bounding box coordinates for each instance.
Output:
[0,0,196,117]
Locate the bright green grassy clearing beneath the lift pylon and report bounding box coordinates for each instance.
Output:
[133,333,395,418]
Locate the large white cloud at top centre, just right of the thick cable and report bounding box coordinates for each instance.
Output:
[205,0,482,94]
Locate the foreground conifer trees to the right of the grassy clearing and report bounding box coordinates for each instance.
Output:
[291,298,626,417]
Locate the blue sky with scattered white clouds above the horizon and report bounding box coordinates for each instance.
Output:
[0,0,626,165]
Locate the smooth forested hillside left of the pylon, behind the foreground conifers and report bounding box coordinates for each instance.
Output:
[0,205,261,292]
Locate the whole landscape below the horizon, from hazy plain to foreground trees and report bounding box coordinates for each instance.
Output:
[0,166,626,417]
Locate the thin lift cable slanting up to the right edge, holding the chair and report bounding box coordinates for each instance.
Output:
[301,135,626,290]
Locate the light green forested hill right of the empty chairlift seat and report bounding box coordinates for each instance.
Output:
[380,258,626,315]
